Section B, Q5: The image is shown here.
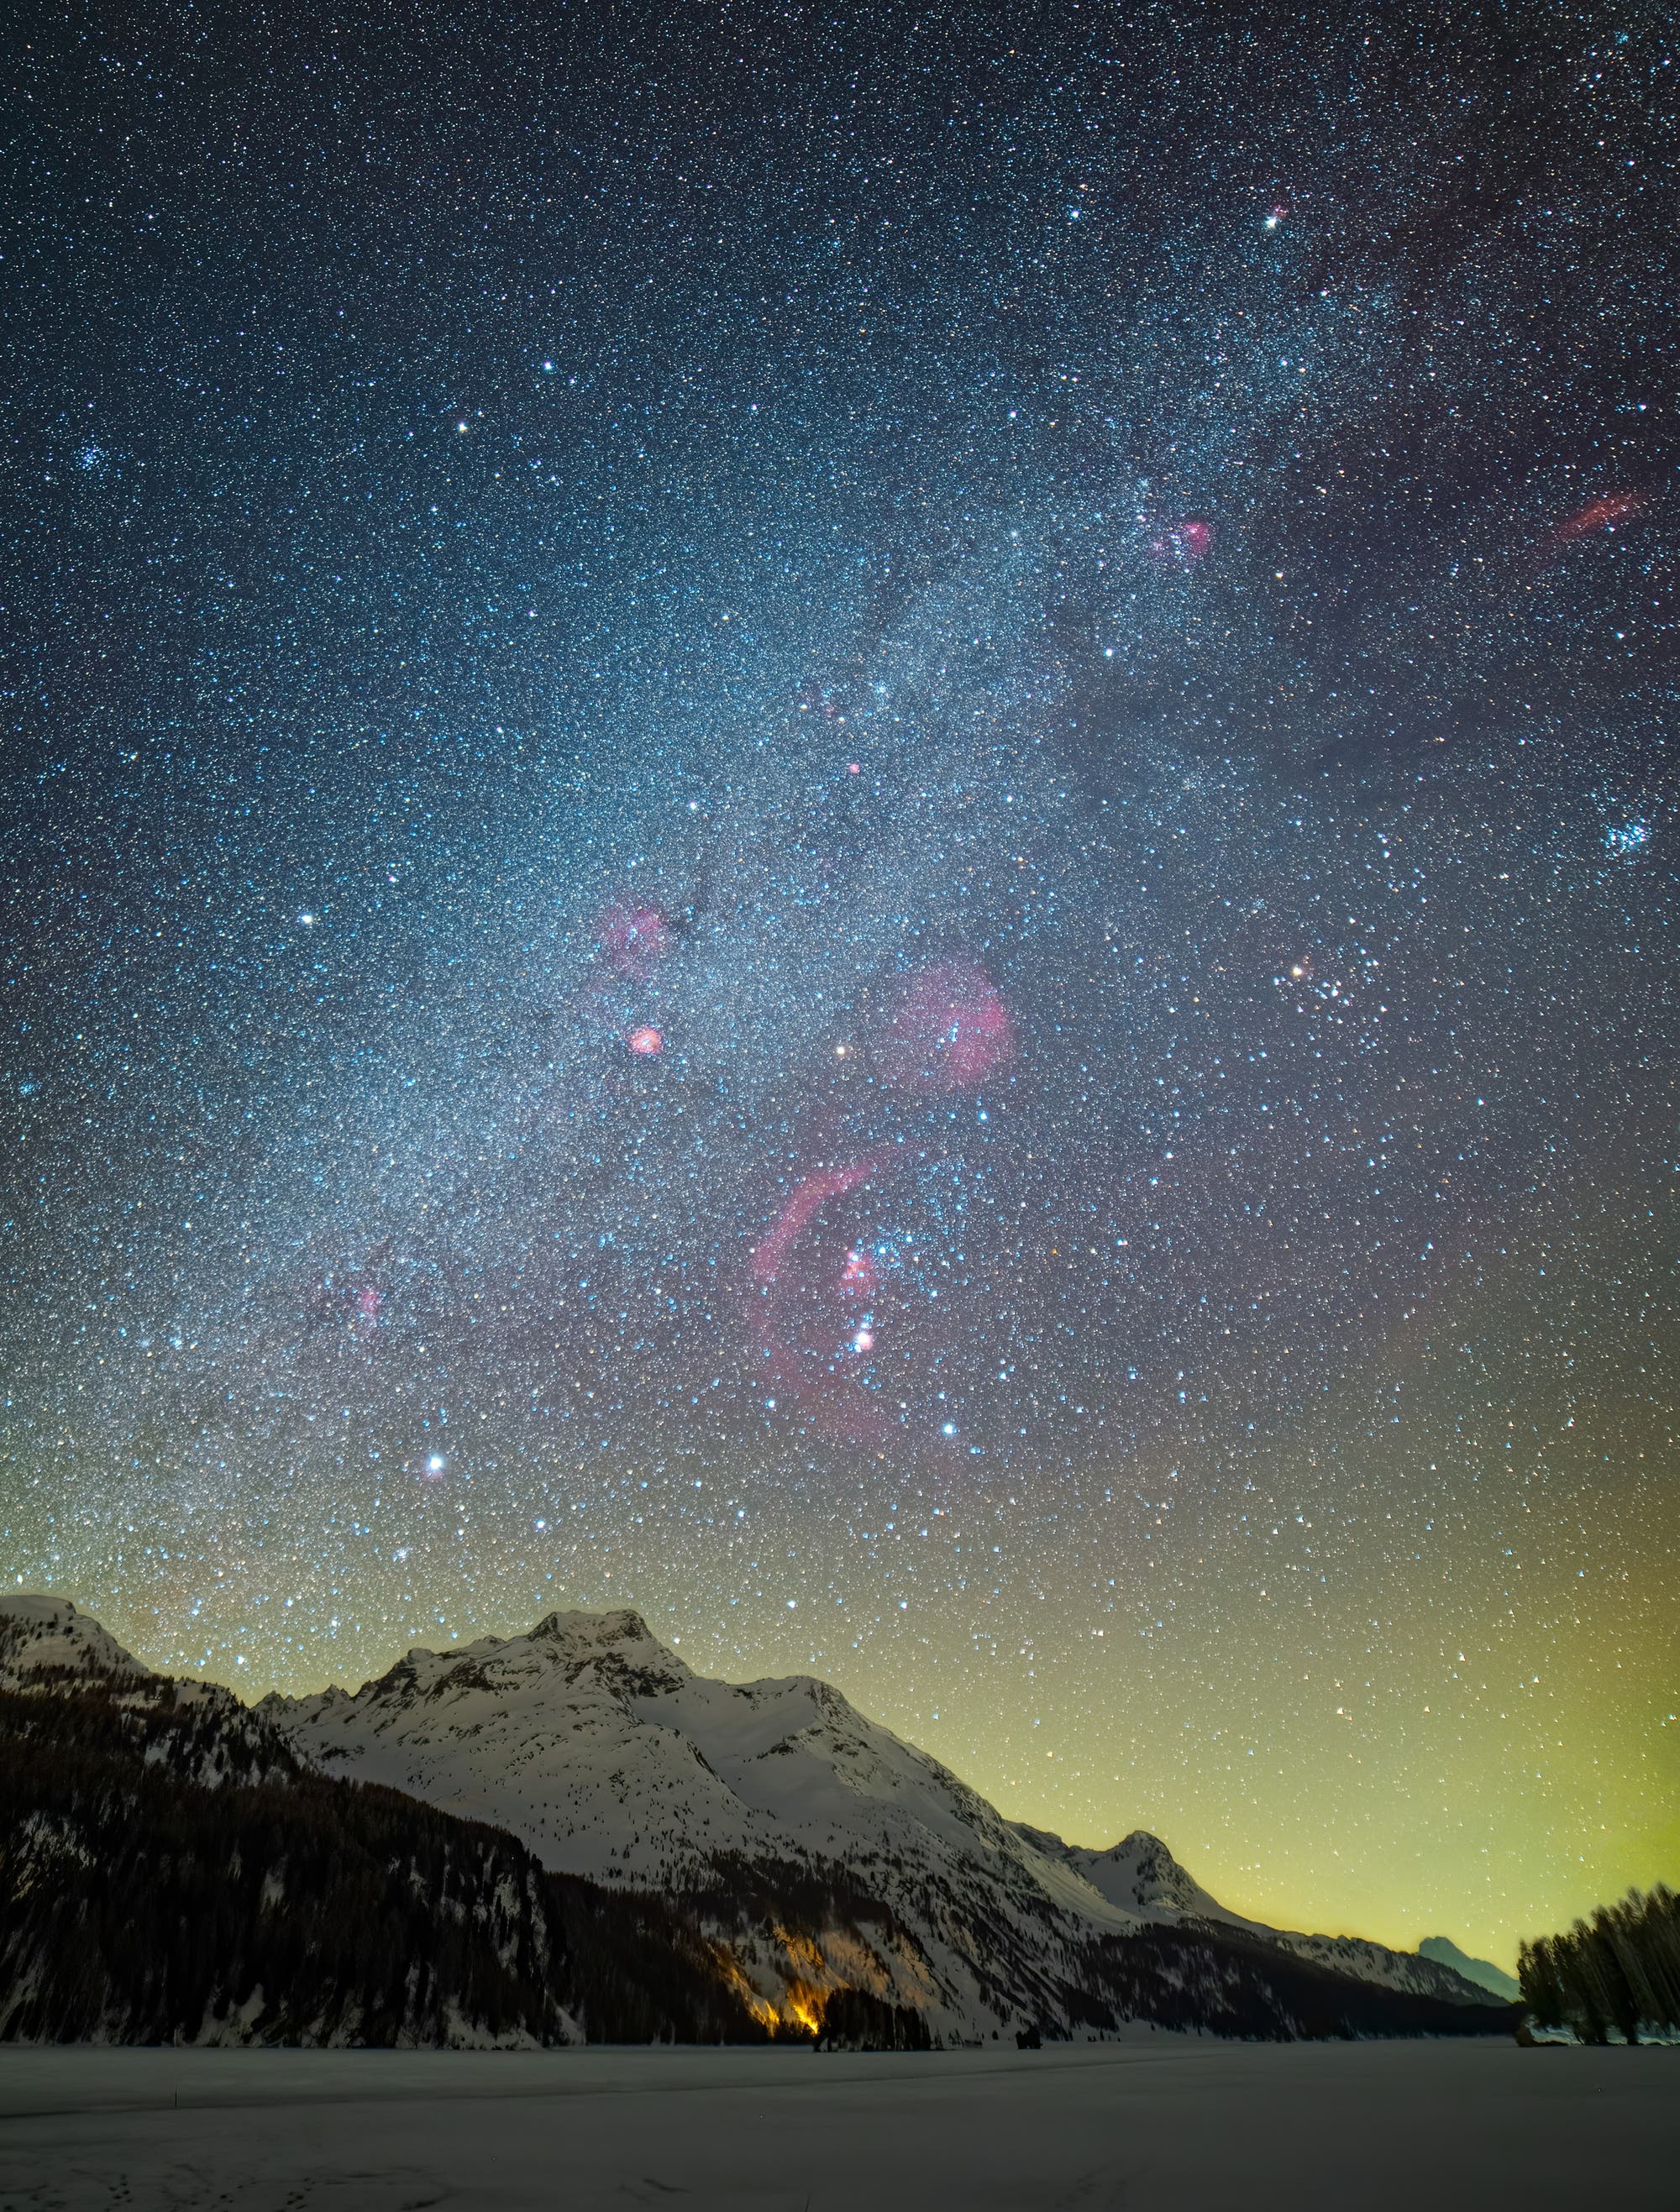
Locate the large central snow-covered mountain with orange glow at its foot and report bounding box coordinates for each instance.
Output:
[259,1612,1485,2040]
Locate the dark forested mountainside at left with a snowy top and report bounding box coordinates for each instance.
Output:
[0,1597,766,2046]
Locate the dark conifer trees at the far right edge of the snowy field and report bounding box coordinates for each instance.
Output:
[1516,1883,1680,2044]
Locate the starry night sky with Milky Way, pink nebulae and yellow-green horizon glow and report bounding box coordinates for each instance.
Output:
[0,0,1680,1960]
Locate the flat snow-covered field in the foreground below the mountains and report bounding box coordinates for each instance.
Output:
[0,2033,1680,2212]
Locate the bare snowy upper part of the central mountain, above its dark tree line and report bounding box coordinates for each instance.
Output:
[259,1612,1110,1925]
